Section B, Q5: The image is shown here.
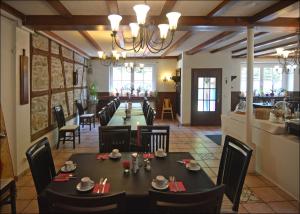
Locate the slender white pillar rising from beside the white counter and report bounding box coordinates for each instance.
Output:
[246,27,255,172]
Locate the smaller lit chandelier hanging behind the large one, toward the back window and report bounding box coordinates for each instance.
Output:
[98,49,127,66]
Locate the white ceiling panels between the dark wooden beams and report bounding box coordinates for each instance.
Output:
[4,0,299,56]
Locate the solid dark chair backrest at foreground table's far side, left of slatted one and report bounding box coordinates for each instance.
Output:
[99,126,131,152]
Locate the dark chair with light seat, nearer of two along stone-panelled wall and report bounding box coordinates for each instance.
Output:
[53,105,80,149]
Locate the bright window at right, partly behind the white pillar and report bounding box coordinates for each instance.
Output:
[240,63,283,95]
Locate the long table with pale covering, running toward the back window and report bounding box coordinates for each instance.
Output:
[107,103,147,131]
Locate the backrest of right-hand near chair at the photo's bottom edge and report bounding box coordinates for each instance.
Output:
[149,185,224,213]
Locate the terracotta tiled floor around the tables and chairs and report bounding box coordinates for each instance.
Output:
[0,120,299,213]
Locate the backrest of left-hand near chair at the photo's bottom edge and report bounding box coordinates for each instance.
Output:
[46,190,125,213]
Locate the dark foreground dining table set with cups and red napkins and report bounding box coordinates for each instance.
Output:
[43,152,215,213]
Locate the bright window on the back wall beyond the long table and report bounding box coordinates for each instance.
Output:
[110,66,155,95]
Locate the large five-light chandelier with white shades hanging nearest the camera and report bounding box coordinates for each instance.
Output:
[108,4,181,53]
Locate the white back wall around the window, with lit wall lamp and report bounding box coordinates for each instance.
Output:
[87,59,177,92]
